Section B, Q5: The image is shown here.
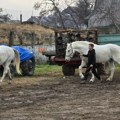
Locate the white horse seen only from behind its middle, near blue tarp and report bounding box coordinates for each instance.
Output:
[0,46,21,83]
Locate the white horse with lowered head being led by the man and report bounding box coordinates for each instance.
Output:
[65,41,120,81]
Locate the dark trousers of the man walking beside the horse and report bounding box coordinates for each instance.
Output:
[85,66,100,80]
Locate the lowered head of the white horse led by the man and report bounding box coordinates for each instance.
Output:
[65,43,75,61]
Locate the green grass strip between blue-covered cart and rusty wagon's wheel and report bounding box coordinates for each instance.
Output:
[35,64,62,75]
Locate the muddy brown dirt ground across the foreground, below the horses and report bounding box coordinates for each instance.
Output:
[0,72,120,120]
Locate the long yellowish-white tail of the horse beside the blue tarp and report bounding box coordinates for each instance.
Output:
[13,49,21,74]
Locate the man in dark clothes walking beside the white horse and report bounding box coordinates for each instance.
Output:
[81,44,101,83]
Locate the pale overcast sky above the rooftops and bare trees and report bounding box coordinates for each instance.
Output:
[0,0,74,21]
